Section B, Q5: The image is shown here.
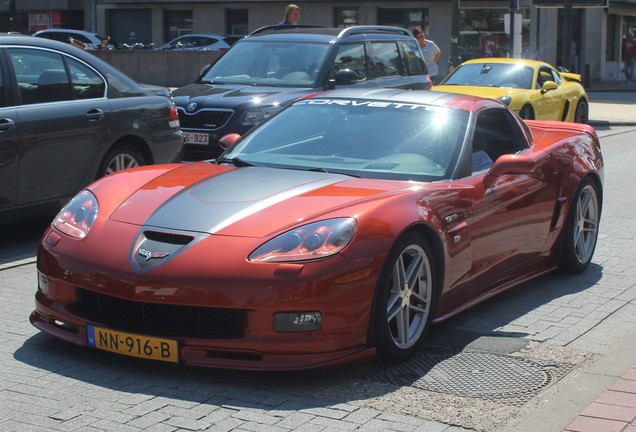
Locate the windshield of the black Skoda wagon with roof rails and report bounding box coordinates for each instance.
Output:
[201,41,329,87]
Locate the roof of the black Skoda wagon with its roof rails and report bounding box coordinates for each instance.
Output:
[244,25,413,42]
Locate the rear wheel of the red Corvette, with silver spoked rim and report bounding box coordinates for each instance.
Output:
[561,178,601,274]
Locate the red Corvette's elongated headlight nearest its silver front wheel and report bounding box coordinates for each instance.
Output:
[249,218,357,262]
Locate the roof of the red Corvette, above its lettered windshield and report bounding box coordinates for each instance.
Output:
[300,88,503,112]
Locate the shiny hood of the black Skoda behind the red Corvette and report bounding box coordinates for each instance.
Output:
[172,84,314,110]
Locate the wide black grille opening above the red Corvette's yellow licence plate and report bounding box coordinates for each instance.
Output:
[75,288,244,339]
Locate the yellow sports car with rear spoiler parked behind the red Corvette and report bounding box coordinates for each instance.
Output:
[433,58,589,123]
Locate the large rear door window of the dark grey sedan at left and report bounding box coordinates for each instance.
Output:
[8,48,72,104]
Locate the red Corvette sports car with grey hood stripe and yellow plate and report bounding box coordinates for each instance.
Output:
[31,89,603,370]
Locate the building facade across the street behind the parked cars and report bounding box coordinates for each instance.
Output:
[0,0,636,81]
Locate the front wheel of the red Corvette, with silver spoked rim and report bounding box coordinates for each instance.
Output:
[374,233,436,362]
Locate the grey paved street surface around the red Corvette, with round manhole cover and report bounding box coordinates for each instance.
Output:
[0,127,636,432]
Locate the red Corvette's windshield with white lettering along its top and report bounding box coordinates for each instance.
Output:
[219,98,469,181]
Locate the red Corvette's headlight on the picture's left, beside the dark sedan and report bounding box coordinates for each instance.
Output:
[53,190,99,239]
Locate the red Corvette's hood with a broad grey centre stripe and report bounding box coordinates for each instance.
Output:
[106,162,405,237]
